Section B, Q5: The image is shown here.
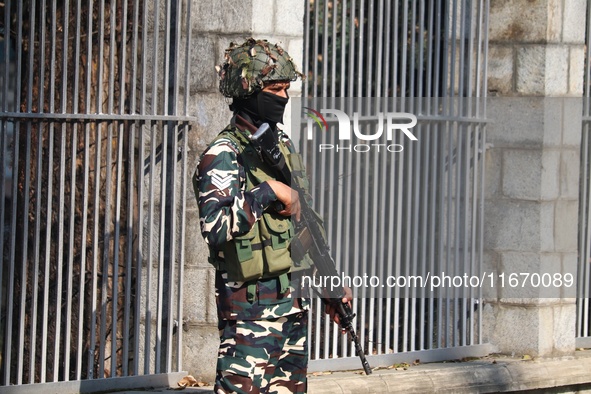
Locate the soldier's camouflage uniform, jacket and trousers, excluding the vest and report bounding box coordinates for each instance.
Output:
[194,122,308,393]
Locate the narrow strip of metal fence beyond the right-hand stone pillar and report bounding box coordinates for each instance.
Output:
[576,1,591,347]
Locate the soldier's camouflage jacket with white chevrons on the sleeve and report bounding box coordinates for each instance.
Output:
[193,122,307,320]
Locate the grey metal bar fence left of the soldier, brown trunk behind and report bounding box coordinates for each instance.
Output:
[0,0,192,391]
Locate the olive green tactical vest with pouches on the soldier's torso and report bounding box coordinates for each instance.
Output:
[210,126,311,286]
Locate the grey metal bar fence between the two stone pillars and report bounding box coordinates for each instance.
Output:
[300,0,490,370]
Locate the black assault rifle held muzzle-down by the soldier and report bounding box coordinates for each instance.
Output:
[250,123,371,375]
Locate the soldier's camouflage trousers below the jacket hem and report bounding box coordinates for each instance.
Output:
[214,312,308,394]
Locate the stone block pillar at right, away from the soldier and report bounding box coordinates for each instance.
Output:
[484,0,586,356]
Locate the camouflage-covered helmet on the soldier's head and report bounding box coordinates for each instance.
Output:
[216,38,303,98]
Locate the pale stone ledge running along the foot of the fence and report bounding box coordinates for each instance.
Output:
[123,350,591,394]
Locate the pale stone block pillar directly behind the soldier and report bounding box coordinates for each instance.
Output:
[183,0,305,381]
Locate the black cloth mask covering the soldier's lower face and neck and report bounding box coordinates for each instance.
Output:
[236,92,289,128]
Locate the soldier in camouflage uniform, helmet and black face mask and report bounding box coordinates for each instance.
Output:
[193,38,350,393]
